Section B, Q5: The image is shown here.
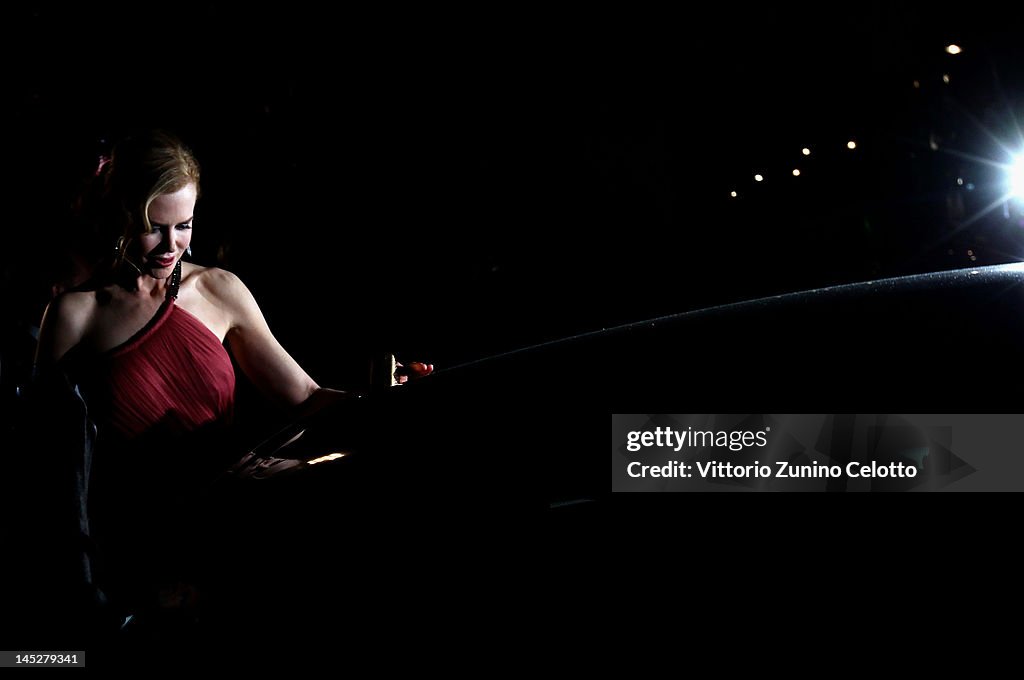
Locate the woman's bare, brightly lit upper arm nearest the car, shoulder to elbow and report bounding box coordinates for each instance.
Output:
[217,269,319,407]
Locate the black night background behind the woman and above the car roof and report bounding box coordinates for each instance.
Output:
[2,2,1024,385]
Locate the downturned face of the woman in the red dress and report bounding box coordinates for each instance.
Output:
[139,184,196,279]
